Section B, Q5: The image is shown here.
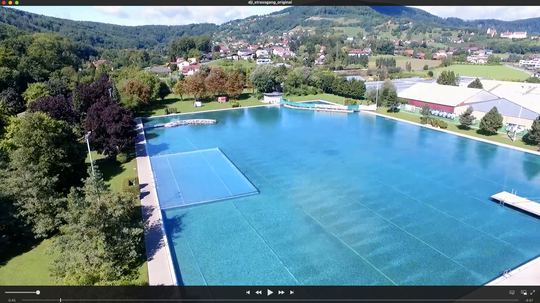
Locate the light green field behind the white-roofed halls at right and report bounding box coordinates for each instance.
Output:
[433,64,529,80]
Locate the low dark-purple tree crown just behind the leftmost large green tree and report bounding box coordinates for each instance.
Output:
[28,96,79,127]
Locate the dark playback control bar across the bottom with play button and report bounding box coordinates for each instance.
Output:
[0,286,540,303]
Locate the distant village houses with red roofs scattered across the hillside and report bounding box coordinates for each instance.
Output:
[90,21,540,76]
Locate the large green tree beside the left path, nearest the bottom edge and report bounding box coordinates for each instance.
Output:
[51,170,143,285]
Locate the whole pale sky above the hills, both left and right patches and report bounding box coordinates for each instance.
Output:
[12,6,540,25]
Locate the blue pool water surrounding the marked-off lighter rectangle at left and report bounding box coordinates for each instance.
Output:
[141,107,540,285]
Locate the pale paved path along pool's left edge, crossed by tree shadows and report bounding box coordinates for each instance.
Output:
[135,119,176,285]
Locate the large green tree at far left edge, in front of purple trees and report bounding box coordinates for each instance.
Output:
[2,113,86,237]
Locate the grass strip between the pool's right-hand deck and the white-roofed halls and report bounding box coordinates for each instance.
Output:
[377,108,538,151]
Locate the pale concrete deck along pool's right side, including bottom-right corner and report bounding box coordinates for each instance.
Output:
[365,112,540,286]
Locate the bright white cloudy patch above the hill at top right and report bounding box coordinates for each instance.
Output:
[413,6,540,21]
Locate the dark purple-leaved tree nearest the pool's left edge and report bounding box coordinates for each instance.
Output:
[85,98,135,157]
